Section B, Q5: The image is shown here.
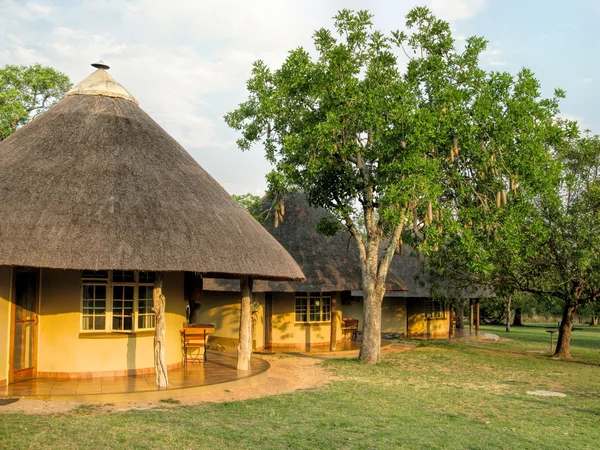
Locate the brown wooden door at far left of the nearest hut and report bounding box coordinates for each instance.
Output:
[9,269,40,383]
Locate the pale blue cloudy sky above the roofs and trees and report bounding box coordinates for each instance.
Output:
[0,0,600,195]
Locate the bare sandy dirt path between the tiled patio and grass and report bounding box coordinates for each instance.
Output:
[0,345,414,414]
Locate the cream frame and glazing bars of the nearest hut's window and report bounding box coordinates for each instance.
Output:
[79,270,154,334]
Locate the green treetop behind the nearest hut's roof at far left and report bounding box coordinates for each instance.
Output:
[0,64,71,141]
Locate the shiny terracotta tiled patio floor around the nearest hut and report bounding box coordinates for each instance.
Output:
[0,351,269,401]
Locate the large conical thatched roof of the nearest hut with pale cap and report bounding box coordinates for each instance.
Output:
[0,69,303,280]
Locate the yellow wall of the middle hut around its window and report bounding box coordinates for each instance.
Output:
[273,292,343,347]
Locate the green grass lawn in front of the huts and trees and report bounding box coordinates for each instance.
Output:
[0,326,600,450]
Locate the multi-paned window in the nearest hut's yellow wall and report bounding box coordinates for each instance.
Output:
[81,270,154,332]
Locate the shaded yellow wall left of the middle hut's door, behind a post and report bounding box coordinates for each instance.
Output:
[193,291,265,349]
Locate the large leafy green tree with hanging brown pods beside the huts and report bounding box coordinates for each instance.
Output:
[225,7,560,362]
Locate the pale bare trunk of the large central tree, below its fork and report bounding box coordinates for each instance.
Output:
[358,279,385,364]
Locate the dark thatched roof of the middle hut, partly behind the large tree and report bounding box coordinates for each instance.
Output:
[204,194,407,292]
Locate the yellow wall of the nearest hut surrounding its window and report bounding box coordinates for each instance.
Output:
[38,269,185,372]
